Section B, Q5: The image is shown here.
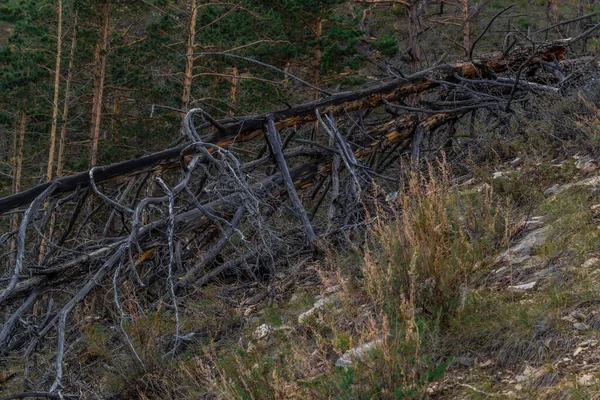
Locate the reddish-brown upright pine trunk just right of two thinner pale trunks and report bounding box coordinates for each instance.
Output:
[89,2,110,168]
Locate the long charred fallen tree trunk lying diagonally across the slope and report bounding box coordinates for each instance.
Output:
[0,40,569,214]
